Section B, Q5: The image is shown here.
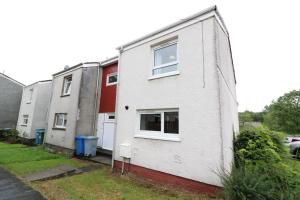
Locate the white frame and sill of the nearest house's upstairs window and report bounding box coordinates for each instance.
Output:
[149,39,179,80]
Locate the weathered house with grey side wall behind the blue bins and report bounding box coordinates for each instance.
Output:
[44,62,101,154]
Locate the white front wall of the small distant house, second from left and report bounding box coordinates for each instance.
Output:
[17,84,38,139]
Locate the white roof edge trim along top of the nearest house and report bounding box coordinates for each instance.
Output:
[117,5,228,50]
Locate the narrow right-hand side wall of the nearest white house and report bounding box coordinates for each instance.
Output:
[215,18,239,171]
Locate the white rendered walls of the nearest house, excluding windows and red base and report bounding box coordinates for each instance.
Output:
[114,14,238,186]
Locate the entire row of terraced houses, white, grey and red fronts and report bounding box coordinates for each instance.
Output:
[0,6,239,193]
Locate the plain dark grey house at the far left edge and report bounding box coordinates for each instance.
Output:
[0,73,24,129]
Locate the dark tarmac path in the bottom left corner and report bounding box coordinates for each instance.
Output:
[0,167,44,200]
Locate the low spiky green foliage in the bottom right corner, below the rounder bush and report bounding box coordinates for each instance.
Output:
[222,162,300,200]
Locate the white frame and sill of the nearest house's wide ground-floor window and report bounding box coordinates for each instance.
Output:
[134,108,181,141]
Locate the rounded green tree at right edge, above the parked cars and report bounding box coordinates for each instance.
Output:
[264,90,300,133]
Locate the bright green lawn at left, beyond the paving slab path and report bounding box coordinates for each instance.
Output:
[0,142,85,176]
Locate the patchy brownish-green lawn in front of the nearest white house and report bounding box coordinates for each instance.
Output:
[33,167,209,200]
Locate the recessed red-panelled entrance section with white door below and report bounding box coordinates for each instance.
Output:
[97,57,118,153]
